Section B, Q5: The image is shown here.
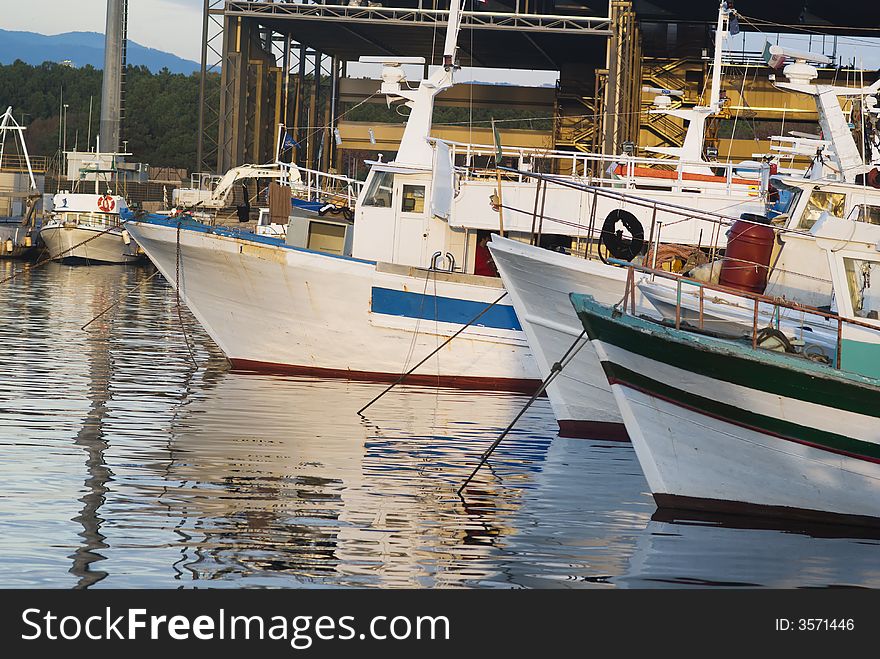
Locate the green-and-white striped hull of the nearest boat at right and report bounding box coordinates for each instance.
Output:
[584,296,880,524]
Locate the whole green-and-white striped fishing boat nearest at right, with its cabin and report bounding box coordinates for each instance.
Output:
[571,215,880,525]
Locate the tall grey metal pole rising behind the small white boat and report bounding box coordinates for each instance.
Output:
[100,0,128,153]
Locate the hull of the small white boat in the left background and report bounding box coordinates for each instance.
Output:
[40,222,141,263]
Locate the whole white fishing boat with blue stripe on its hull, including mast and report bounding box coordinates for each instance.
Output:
[120,3,761,391]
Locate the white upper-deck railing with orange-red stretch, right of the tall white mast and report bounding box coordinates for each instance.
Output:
[429,138,767,196]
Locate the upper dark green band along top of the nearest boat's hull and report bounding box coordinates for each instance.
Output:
[571,293,880,418]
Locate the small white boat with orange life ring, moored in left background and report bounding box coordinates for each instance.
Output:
[40,192,143,263]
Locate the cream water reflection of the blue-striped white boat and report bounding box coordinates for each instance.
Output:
[163,374,552,586]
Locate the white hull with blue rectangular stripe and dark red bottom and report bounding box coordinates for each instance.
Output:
[126,220,538,391]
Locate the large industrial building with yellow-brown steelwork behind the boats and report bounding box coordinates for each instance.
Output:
[198,0,880,178]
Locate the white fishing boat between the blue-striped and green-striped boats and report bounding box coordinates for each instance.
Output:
[489,45,880,438]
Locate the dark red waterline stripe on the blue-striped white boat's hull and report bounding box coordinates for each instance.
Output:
[229,359,546,395]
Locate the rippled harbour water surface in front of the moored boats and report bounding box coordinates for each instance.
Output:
[0,261,880,588]
